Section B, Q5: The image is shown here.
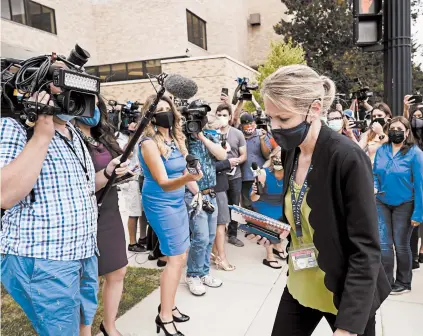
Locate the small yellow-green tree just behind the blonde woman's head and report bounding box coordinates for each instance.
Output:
[245,40,305,112]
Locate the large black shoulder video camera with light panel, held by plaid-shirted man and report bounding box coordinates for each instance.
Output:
[1,44,100,126]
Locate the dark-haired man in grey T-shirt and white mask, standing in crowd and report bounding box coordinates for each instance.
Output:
[216,104,247,247]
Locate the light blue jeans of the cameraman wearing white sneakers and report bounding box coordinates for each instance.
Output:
[185,192,218,277]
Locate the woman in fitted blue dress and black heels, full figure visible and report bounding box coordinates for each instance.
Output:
[139,95,203,336]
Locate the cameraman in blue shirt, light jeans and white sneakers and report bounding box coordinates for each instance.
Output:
[185,100,227,296]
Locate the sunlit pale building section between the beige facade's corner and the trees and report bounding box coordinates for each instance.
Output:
[247,0,289,66]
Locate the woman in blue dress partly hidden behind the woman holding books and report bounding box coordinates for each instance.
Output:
[250,147,287,269]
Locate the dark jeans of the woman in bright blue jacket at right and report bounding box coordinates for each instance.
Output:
[376,200,414,289]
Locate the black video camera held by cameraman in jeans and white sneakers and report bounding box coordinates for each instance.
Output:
[180,99,211,136]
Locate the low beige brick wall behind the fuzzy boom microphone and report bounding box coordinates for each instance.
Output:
[101,56,256,108]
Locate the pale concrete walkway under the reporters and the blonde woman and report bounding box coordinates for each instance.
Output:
[112,207,423,336]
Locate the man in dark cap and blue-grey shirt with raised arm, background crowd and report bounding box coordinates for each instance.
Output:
[241,112,272,210]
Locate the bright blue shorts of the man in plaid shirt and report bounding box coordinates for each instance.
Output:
[1,254,98,336]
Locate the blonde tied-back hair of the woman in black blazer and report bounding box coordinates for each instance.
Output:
[261,64,336,115]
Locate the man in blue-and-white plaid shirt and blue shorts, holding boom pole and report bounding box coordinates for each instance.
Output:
[0,86,128,336]
